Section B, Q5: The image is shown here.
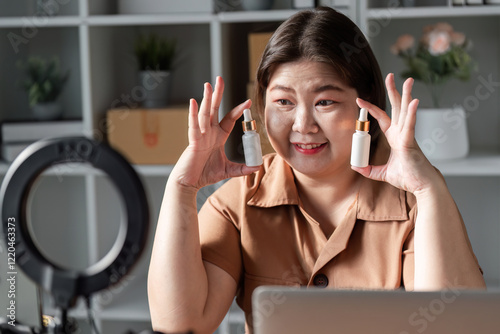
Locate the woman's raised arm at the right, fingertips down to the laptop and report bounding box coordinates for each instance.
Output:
[353,74,485,290]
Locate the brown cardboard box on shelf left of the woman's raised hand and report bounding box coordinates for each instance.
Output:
[107,106,189,165]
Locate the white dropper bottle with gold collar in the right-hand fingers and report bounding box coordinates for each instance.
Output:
[351,108,371,167]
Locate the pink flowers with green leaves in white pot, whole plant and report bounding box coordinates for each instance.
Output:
[391,22,475,159]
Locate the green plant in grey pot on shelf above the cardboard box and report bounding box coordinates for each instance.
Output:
[135,33,177,108]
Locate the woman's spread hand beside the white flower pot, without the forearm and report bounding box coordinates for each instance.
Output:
[352,73,441,194]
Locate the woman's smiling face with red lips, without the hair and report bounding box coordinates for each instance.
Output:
[265,60,359,177]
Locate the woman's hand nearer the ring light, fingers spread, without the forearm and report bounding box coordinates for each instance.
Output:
[171,77,260,189]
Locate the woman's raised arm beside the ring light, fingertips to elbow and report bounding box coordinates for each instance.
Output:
[148,78,258,333]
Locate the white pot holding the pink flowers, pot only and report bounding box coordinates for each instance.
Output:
[415,107,469,160]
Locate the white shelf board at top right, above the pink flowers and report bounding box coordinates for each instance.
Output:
[367,6,500,20]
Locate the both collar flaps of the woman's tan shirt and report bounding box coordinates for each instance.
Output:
[247,154,408,221]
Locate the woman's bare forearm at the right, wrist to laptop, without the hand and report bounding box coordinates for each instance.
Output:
[414,177,486,290]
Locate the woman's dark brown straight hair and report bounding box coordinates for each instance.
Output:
[254,7,385,149]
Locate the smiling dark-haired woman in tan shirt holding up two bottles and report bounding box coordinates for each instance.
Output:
[149,8,484,333]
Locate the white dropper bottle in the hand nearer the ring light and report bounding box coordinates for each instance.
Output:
[242,109,262,167]
